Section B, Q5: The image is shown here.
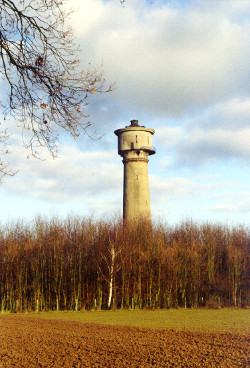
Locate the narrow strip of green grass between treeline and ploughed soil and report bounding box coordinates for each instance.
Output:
[9,308,250,334]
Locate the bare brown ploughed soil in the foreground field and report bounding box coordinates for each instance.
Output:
[0,315,250,368]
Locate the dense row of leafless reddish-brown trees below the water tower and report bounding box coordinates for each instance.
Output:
[0,217,250,312]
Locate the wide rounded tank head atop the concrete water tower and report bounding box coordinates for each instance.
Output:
[114,120,155,156]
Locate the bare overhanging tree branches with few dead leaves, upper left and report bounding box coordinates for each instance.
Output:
[0,0,112,178]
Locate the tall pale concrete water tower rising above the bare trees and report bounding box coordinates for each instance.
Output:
[114,120,155,221]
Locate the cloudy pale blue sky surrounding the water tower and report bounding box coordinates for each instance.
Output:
[0,0,250,226]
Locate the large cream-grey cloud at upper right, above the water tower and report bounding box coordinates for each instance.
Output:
[68,0,249,116]
